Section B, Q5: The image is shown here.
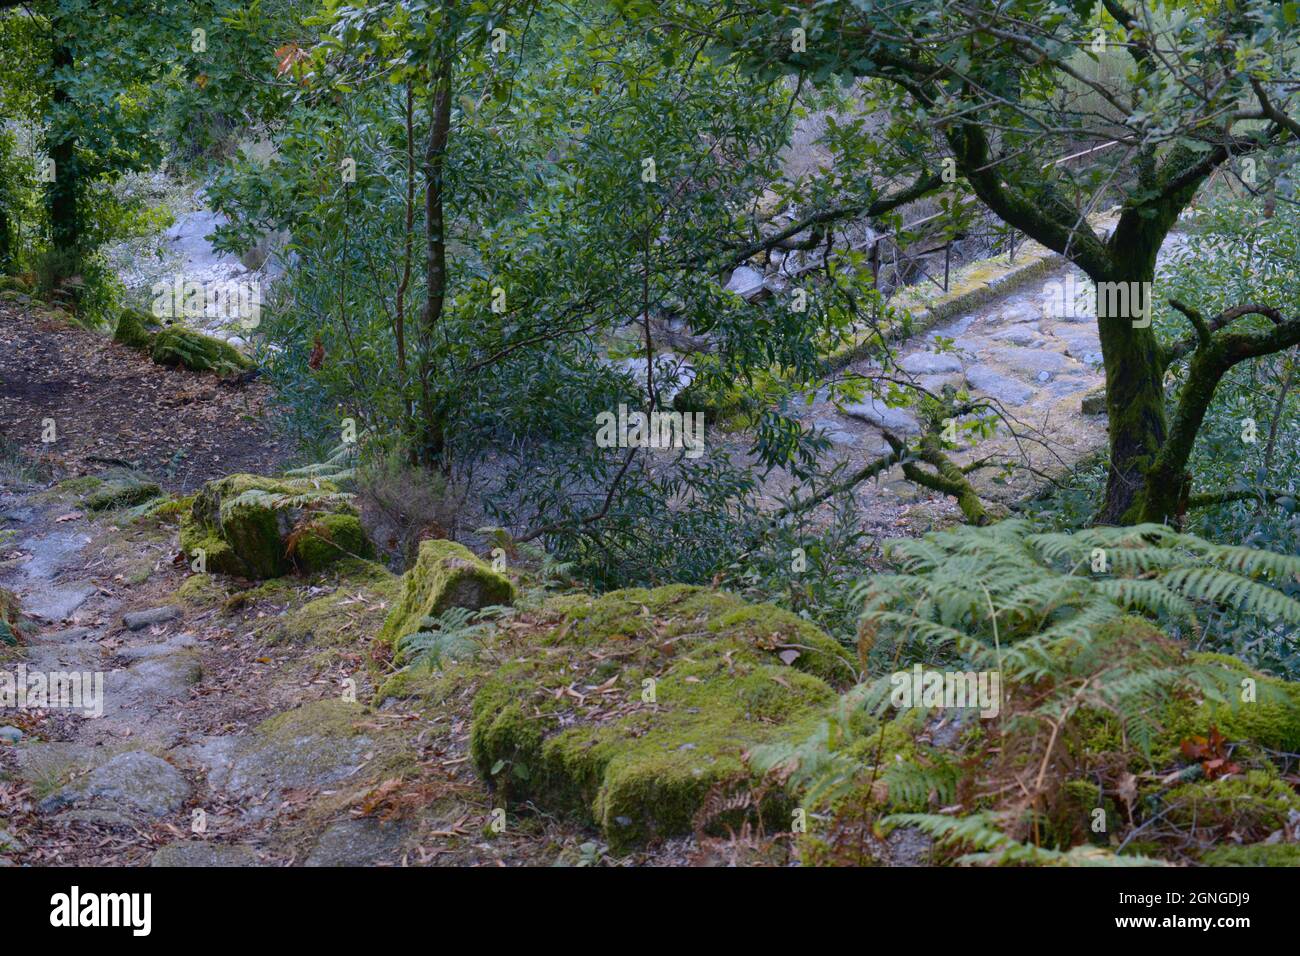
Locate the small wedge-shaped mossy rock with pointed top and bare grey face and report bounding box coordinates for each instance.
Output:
[378,540,515,646]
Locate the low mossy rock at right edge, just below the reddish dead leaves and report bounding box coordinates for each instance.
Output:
[1164,770,1300,839]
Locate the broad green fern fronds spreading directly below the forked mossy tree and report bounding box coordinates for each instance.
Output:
[858,519,1300,679]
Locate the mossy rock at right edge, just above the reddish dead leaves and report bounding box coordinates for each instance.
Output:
[1164,654,1300,753]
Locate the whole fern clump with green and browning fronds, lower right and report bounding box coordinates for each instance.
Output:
[754,520,1300,865]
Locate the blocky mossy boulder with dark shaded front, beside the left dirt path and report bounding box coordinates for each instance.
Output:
[181,475,371,579]
